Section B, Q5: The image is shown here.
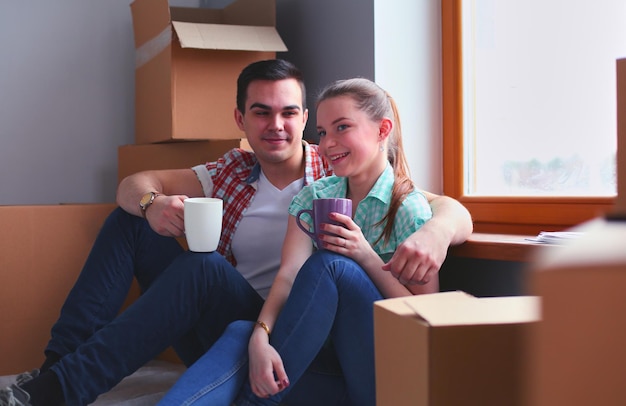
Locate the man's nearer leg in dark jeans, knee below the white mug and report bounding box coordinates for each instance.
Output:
[51,252,263,405]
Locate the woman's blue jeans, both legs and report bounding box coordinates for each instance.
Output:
[162,250,382,406]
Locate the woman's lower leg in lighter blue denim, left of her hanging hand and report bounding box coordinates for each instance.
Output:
[159,320,254,406]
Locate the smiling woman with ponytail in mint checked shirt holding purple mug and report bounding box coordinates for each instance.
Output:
[162,78,438,406]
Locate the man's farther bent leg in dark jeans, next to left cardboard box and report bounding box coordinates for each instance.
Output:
[45,208,183,364]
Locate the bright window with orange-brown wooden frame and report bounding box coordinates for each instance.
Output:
[442,0,626,234]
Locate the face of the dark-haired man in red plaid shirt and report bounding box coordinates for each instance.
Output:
[235,79,308,164]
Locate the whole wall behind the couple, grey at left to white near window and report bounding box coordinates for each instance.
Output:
[0,0,441,205]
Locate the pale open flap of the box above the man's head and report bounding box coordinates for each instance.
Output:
[172,21,287,52]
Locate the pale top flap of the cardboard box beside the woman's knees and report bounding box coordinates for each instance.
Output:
[405,296,540,327]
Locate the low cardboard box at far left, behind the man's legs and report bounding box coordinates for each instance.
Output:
[0,204,118,375]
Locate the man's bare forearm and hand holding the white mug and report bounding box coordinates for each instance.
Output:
[116,169,204,237]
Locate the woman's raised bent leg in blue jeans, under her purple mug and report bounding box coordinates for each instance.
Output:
[237,251,380,406]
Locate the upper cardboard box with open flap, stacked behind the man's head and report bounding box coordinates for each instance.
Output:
[131,0,287,144]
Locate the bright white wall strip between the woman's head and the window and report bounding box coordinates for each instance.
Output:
[374,0,443,193]
